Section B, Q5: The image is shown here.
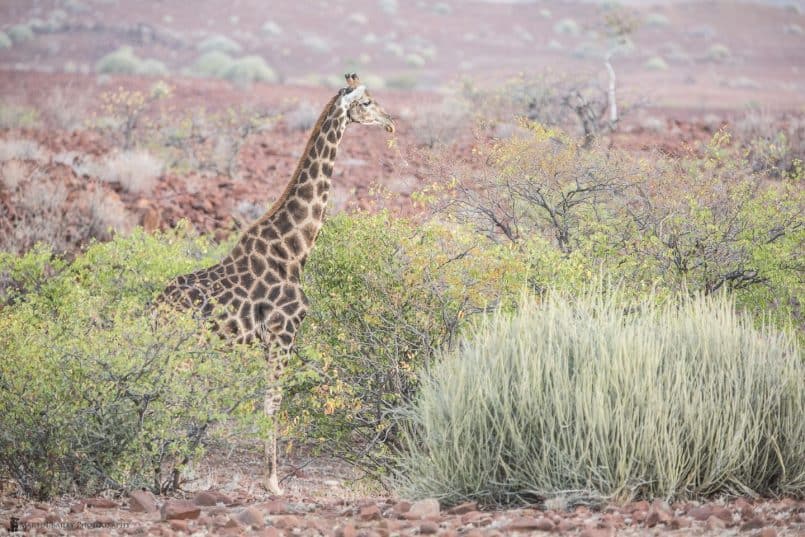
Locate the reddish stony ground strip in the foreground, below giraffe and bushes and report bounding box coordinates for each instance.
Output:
[0,450,805,537]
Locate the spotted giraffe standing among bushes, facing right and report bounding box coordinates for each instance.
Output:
[158,73,394,495]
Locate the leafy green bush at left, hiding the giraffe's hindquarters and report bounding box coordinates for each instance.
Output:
[0,229,265,498]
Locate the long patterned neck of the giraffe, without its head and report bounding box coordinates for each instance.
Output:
[230,96,348,280]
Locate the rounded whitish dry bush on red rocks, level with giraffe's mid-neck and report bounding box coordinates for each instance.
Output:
[95,150,165,195]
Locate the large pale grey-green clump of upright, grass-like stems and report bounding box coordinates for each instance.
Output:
[399,292,805,504]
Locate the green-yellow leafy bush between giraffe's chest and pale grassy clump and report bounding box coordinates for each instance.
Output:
[286,214,526,471]
